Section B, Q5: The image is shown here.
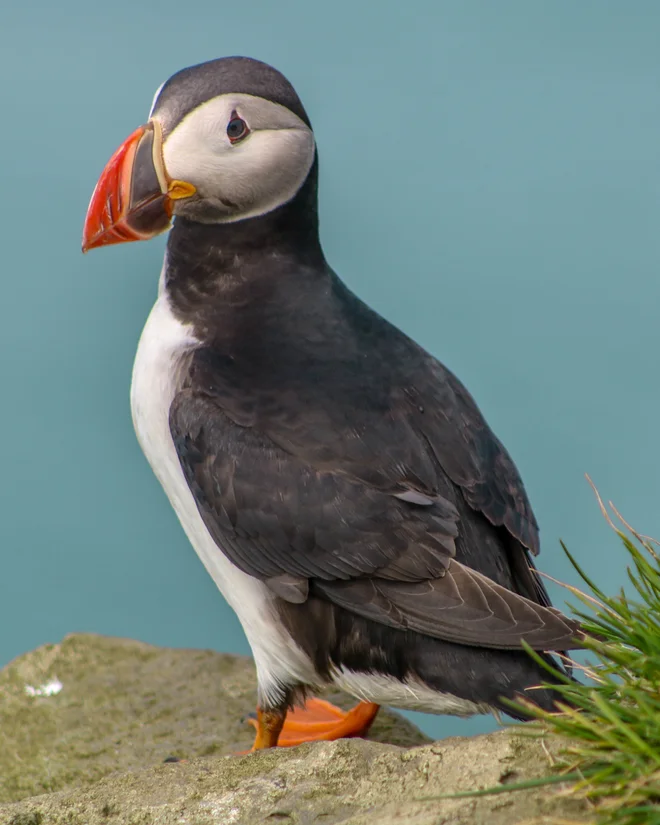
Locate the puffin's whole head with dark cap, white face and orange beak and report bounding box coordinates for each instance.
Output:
[82,57,316,252]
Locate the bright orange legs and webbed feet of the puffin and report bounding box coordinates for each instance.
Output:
[248,699,379,751]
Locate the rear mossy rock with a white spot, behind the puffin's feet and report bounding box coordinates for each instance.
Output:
[0,634,430,802]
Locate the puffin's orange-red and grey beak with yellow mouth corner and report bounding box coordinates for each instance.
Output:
[82,121,196,252]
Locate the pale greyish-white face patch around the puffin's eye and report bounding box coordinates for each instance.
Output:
[152,93,315,223]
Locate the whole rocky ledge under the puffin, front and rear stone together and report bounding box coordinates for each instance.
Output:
[0,635,587,825]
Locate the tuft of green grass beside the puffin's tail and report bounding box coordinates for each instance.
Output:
[506,482,660,825]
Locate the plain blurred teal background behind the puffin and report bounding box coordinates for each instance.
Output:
[0,0,660,735]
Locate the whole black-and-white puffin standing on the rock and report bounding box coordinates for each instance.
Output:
[83,57,584,750]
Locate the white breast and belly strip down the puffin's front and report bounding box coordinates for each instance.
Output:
[131,280,318,703]
